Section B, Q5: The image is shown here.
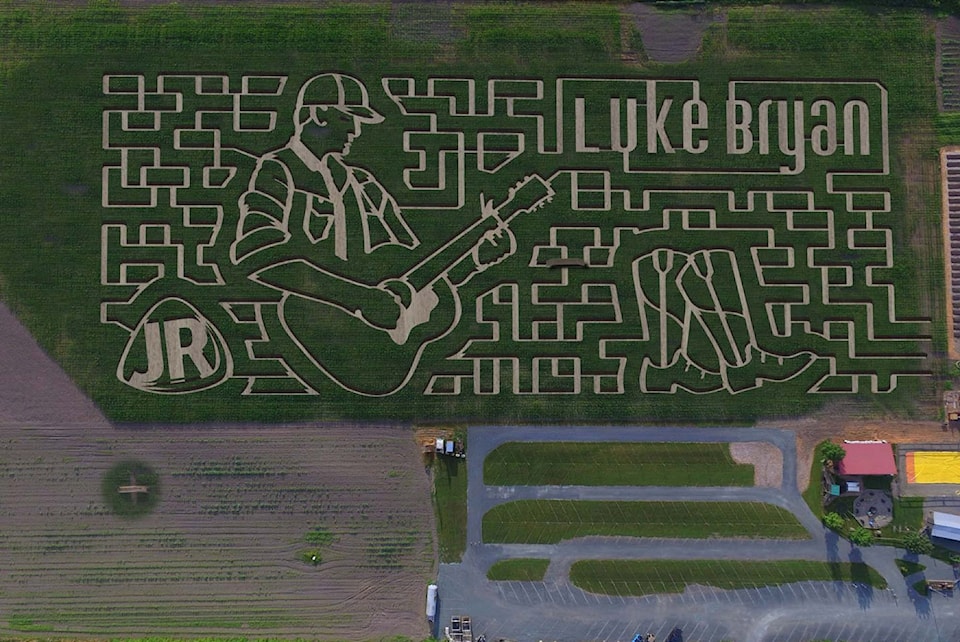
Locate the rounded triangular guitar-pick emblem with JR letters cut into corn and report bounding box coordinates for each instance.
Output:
[117,298,233,394]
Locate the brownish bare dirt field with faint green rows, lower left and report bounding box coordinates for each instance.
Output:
[0,308,436,639]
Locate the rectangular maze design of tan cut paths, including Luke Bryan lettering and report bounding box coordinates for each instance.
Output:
[101,73,926,410]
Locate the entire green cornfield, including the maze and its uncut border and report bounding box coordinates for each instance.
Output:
[2,5,949,421]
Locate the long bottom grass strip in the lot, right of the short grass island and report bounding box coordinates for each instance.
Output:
[570,560,887,595]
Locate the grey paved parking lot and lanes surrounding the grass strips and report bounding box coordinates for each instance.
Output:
[437,426,960,642]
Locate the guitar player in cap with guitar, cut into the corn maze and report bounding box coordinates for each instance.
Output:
[230,73,553,396]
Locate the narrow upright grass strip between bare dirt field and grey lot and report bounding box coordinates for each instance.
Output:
[433,450,467,562]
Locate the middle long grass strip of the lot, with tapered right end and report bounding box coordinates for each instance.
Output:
[483,499,809,544]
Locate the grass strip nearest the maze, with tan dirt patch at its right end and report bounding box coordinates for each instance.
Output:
[483,442,753,486]
